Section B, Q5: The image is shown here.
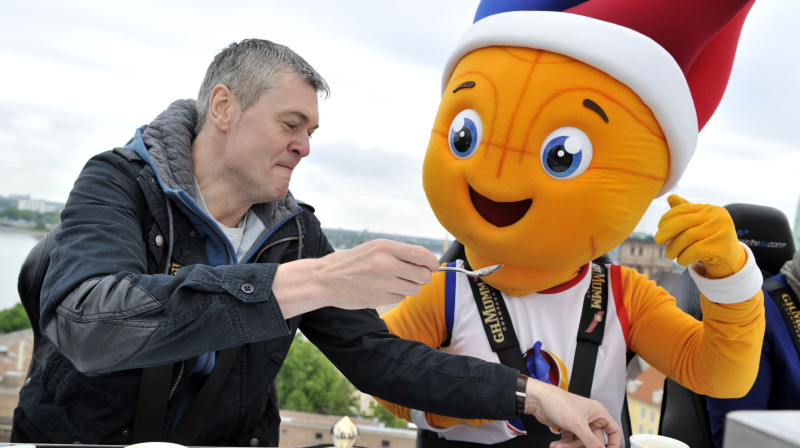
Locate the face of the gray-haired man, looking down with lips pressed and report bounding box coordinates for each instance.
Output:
[225,73,319,203]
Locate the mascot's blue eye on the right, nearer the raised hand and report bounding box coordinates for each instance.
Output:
[542,127,593,180]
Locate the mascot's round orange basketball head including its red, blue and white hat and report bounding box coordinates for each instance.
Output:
[423,0,751,295]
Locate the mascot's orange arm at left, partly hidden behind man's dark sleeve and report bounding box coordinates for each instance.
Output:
[375,272,486,428]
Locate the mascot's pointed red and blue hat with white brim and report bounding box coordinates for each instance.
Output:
[442,0,754,196]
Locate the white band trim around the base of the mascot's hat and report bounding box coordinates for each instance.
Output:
[442,11,698,196]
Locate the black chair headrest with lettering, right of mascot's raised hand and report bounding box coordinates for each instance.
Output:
[725,204,795,278]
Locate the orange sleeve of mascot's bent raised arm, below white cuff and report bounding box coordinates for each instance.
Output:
[621,267,765,398]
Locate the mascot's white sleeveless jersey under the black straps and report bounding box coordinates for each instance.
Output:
[411,260,628,444]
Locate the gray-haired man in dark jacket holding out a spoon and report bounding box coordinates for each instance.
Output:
[12,40,620,447]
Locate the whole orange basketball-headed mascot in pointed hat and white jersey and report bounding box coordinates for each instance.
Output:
[381,0,764,446]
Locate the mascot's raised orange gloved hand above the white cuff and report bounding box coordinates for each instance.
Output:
[655,194,747,279]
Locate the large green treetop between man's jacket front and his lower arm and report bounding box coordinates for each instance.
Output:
[278,333,357,415]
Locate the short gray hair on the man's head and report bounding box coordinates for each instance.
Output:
[195,39,330,133]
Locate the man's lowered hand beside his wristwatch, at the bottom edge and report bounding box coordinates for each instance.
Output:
[525,379,622,448]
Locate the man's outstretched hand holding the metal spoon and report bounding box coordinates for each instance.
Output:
[272,240,439,319]
